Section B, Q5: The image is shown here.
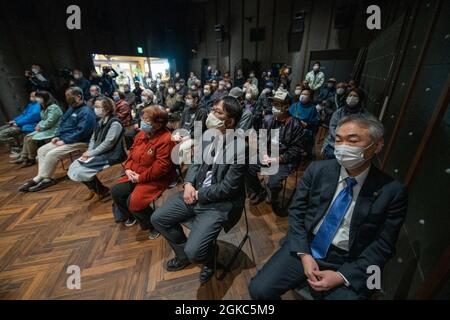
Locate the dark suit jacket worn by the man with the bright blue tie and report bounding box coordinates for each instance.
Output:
[287,160,407,292]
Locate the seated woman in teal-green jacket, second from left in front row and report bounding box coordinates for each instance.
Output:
[11,91,63,168]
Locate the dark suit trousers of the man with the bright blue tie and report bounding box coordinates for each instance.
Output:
[249,239,367,300]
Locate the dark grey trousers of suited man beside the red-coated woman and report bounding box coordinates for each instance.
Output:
[151,192,228,267]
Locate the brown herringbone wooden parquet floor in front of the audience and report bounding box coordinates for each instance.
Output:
[0,150,306,300]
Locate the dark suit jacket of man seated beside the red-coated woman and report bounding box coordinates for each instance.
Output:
[184,138,247,232]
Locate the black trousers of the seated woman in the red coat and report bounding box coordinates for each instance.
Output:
[111,181,155,230]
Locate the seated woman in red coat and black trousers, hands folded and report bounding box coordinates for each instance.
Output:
[111,105,176,239]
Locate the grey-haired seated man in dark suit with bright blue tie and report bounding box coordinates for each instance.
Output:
[249,114,407,299]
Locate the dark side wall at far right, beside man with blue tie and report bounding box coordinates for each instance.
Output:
[362,0,450,298]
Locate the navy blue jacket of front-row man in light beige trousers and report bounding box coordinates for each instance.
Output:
[56,104,97,144]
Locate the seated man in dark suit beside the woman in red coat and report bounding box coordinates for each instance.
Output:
[151,96,246,283]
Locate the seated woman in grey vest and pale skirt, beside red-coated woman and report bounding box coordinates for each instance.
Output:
[67,97,126,201]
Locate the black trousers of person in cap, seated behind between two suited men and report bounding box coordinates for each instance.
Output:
[245,163,297,202]
